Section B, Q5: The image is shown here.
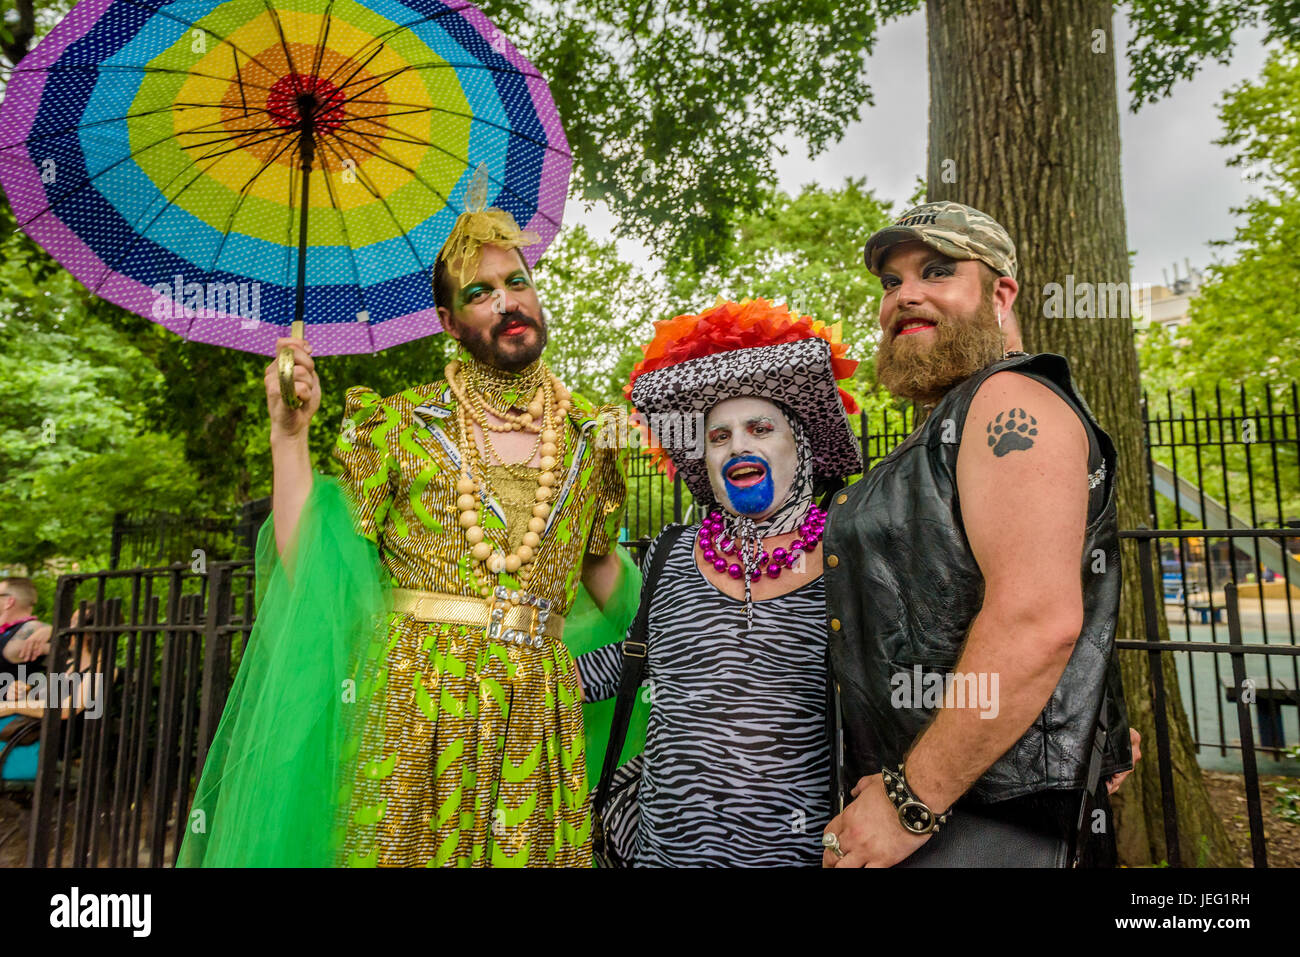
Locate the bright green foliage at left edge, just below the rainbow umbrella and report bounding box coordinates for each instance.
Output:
[0,207,196,570]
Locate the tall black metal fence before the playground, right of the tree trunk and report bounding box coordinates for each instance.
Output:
[1143,382,1300,770]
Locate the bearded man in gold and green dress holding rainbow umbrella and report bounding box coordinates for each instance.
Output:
[195,209,640,866]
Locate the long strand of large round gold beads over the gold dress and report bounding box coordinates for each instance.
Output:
[447,361,572,598]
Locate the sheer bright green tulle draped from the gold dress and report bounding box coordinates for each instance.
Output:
[177,473,649,867]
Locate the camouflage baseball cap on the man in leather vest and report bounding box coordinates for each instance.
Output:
[863,203,1015,280]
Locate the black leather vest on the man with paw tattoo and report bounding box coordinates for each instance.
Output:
[823,354,1130,802]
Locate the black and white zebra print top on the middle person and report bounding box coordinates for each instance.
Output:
[577,525,831,867]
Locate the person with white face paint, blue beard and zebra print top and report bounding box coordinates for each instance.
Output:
[577,300,861,867]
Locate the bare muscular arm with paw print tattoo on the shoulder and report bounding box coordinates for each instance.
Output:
[906,372,1088,810]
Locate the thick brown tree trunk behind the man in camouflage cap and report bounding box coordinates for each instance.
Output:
[926,0,1238,866]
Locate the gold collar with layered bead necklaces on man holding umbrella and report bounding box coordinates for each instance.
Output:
[447,360,572,603]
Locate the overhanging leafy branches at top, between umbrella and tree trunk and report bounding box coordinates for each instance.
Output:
[484,0,919,268]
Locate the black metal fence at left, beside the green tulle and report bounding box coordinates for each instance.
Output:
[12,562,254,867]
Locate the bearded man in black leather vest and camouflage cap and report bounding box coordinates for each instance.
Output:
[823,203,1136,867]
